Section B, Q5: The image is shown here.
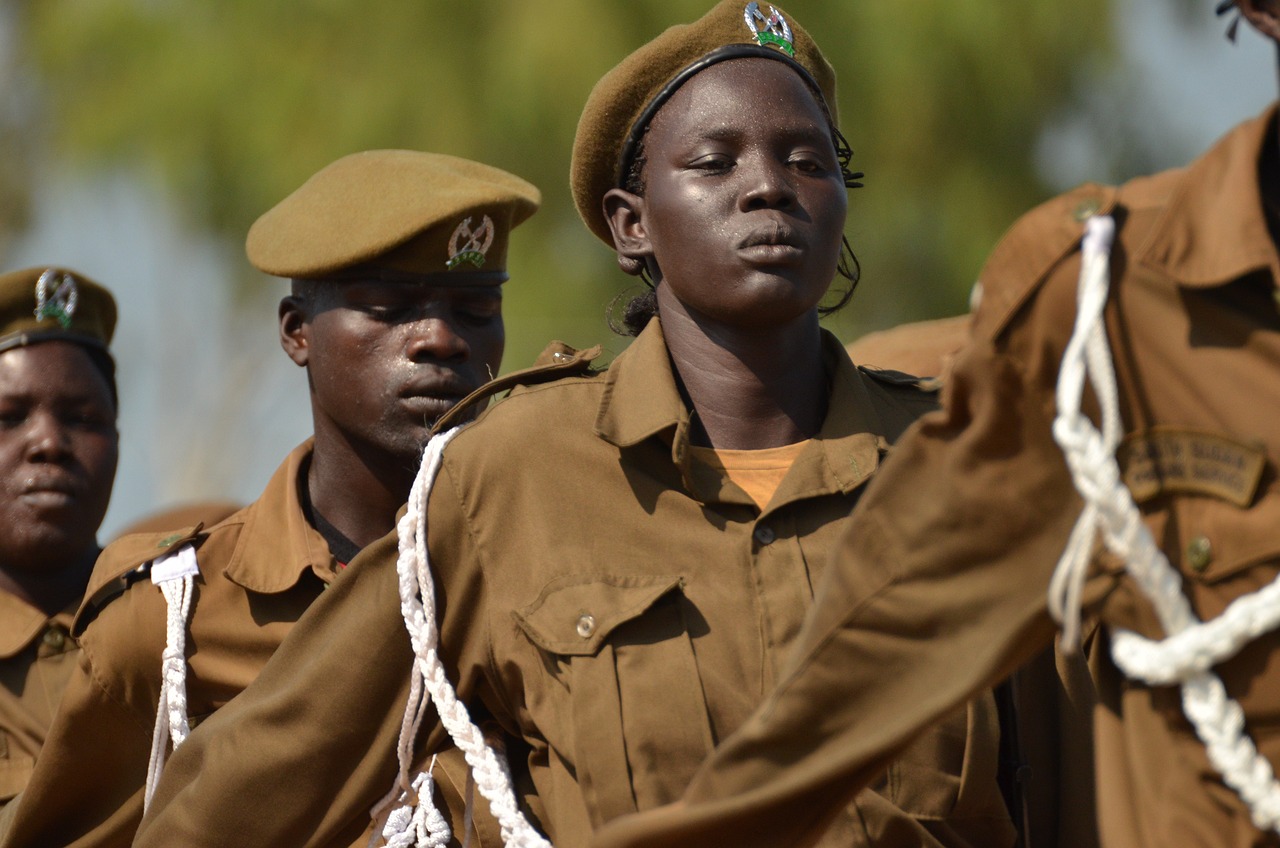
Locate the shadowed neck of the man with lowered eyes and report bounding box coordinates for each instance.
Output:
[307,428,417,547]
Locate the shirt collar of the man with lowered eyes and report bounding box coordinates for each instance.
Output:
[227,439,337,593]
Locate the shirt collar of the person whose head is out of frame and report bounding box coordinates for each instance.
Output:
[1135,105,1280,287]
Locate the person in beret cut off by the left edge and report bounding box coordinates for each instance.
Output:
[0,268,119,807]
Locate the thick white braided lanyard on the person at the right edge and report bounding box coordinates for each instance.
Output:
[1048,216,1280,830]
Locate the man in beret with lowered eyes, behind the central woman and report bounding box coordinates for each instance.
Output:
[4,150,539,848]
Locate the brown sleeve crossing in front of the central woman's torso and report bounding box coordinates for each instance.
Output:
[593,342,1080,848]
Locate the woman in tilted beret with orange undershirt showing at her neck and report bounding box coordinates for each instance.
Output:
[137,0,1014,848]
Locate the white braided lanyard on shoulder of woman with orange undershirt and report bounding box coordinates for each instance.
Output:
[371,428,550,848]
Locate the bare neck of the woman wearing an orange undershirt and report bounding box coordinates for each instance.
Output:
[658,286,828,450]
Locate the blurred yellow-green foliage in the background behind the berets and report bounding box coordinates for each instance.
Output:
[10,0,1112,369]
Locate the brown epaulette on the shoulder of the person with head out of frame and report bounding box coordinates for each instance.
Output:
[973,183,1117,339]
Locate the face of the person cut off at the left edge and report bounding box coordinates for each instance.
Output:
[0,342,119,570]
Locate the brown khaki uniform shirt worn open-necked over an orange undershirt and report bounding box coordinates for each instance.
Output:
[129,322,1012,848]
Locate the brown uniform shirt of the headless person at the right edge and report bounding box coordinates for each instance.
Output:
[596,109,1280,848]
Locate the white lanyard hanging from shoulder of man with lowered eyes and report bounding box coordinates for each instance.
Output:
[142,544,200,812]
